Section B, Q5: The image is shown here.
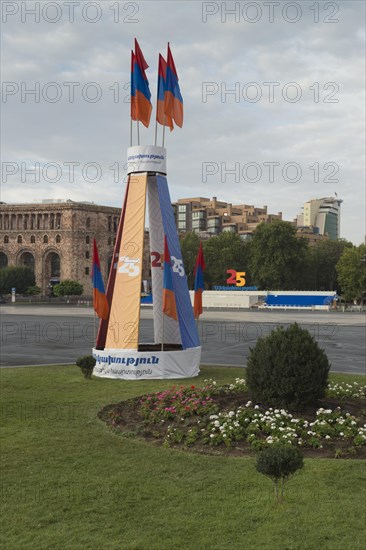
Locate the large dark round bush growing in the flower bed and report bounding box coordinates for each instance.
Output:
[246,323,330,409]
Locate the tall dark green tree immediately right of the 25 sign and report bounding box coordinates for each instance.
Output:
[250,220,309,290]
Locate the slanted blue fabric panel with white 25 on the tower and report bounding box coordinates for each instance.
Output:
[156,174,200,349]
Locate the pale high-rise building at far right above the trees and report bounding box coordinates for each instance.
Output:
[297,197,343,240]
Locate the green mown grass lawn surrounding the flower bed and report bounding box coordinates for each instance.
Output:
[1,366,366,550]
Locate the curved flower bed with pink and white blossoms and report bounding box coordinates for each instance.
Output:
[99,379,366,458]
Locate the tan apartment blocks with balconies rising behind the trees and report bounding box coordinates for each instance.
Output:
[173,197,282,239]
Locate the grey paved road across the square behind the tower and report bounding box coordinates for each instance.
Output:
[0,305,366,374]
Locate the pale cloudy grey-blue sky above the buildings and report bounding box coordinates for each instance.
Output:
[1,0,366,244]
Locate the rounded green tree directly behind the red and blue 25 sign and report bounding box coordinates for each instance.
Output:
[203,232,250,286]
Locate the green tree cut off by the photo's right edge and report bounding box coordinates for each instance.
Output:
[336,244,366,302]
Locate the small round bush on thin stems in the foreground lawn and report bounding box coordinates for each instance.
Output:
[256,445,304,501]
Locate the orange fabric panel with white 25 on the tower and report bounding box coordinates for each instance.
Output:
[105,173,147,350]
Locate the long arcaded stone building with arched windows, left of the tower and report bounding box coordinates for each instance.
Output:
[0,200,150,295]
